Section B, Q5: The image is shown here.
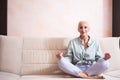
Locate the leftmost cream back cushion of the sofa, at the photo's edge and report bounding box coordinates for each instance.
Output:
[0,36,23,74]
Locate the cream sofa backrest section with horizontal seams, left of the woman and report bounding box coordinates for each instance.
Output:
[21,38,69,75]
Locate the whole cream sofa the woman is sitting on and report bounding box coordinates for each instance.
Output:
[0,35,120,80]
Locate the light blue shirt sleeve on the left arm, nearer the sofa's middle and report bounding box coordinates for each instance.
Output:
[65,41,73,62]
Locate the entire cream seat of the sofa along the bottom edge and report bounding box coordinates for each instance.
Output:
[0,70,120,80]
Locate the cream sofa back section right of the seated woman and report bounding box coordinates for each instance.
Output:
[98,37,120,71]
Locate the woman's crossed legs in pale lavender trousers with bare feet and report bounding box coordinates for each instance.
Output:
[58,57,109,79]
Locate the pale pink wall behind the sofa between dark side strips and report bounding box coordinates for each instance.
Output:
[7,0,112,37]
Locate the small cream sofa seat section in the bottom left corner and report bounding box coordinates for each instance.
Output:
[0,72,20,80]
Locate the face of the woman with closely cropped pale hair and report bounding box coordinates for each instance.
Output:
[78,22,89,36]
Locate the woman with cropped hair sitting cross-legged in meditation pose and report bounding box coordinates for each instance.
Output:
[56,21,111,79]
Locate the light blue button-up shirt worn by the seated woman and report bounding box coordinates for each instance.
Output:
[65,37,102,64]
